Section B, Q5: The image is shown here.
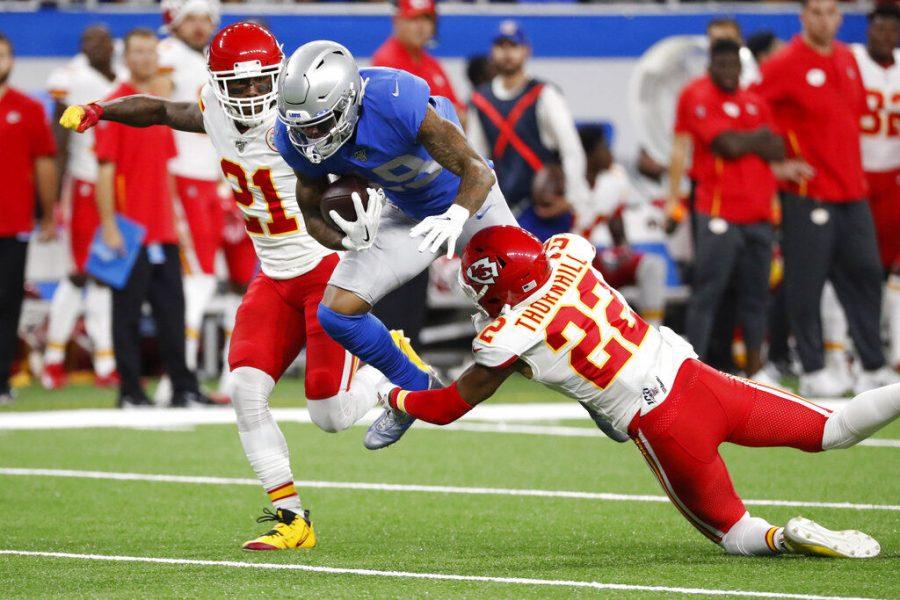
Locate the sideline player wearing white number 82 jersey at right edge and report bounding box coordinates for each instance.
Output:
[851,4,900,369]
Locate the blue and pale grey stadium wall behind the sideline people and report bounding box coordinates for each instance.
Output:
[0,4,865,164]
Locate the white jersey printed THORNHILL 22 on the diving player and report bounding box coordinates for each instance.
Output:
[472,234,697,434]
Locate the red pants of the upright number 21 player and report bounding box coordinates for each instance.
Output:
[228,254,358,400]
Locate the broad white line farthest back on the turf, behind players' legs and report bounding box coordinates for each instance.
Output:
[0,400,900,448]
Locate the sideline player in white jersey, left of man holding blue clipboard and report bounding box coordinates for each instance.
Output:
[41,25,118,389]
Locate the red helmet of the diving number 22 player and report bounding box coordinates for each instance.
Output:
[459,225,550,318]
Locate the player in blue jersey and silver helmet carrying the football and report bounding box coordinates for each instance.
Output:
[275,41,516,449]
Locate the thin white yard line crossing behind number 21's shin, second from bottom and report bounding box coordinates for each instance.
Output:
[0,467,900,511]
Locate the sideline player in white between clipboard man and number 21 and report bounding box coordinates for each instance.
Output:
[157,0,256,399]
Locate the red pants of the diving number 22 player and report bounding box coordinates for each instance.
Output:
[628,359,831,543]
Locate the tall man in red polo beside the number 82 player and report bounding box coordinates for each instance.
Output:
[756,0,897,395]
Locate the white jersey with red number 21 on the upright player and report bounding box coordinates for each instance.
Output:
[200,85,333,279]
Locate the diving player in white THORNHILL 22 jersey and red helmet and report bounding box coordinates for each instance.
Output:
[379,226,900,558]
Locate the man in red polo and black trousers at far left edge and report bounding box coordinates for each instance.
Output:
[0,33,58,405]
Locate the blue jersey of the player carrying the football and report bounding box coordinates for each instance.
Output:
[275,67,459,219]
